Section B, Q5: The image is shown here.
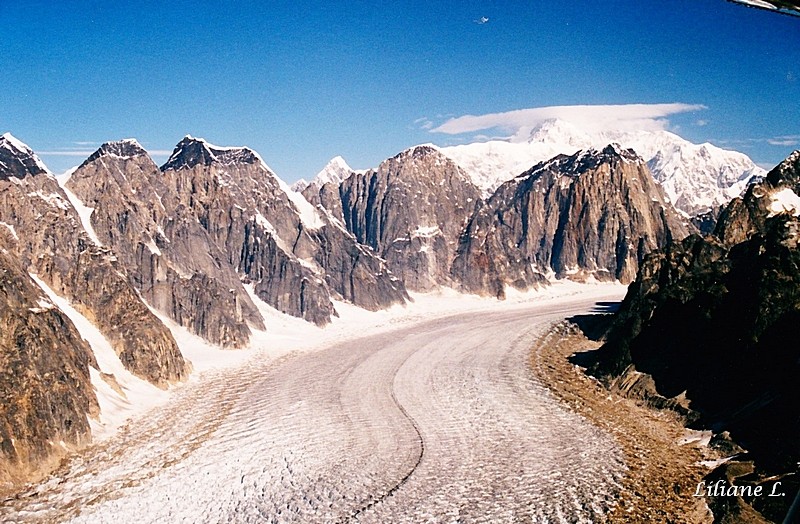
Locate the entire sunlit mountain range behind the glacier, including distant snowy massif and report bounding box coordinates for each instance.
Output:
[0,128,760,496]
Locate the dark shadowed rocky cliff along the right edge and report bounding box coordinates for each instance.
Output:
[592,152,800,521]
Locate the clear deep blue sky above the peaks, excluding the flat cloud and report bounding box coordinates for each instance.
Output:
[0,0,800,181]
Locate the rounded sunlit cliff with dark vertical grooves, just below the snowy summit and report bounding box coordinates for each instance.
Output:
[452,146,687,296]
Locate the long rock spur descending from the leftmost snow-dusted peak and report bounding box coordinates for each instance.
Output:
[0,137,188,387]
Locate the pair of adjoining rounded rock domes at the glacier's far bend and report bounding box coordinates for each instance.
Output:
[303,145,692,297]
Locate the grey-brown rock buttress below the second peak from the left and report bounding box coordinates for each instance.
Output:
[65,140,264,347]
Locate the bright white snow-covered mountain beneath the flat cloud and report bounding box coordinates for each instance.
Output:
[441,119,765,215]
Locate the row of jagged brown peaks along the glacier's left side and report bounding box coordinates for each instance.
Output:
[0,135,407,494]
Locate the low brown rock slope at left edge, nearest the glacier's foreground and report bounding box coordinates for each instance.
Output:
[0,248,99,492]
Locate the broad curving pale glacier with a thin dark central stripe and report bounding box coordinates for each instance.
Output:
[0,282,625,522]
